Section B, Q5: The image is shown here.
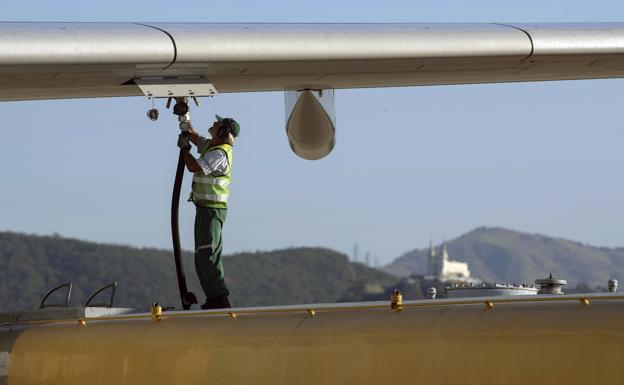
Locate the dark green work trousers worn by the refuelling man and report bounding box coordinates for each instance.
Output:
[195,206,230,301]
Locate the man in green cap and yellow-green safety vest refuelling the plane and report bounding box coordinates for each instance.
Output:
[178,115,240,309]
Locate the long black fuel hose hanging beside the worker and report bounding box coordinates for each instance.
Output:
[171,143,197,310]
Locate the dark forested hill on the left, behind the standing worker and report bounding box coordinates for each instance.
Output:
[0,232,397,311]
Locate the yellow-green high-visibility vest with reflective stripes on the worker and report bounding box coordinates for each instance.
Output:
[193,144,232,208]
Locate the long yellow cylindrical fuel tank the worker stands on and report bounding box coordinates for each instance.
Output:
[0,294,624,385]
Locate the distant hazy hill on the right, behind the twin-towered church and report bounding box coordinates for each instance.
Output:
[383,227,624,287]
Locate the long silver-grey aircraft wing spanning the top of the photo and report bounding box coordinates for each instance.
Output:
[0,22,624,100]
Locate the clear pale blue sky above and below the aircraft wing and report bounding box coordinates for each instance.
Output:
[0,0,624,263]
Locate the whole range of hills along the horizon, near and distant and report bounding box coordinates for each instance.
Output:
[0,228,624,311]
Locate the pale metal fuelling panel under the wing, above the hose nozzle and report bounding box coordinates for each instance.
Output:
[134,77,218,98]
